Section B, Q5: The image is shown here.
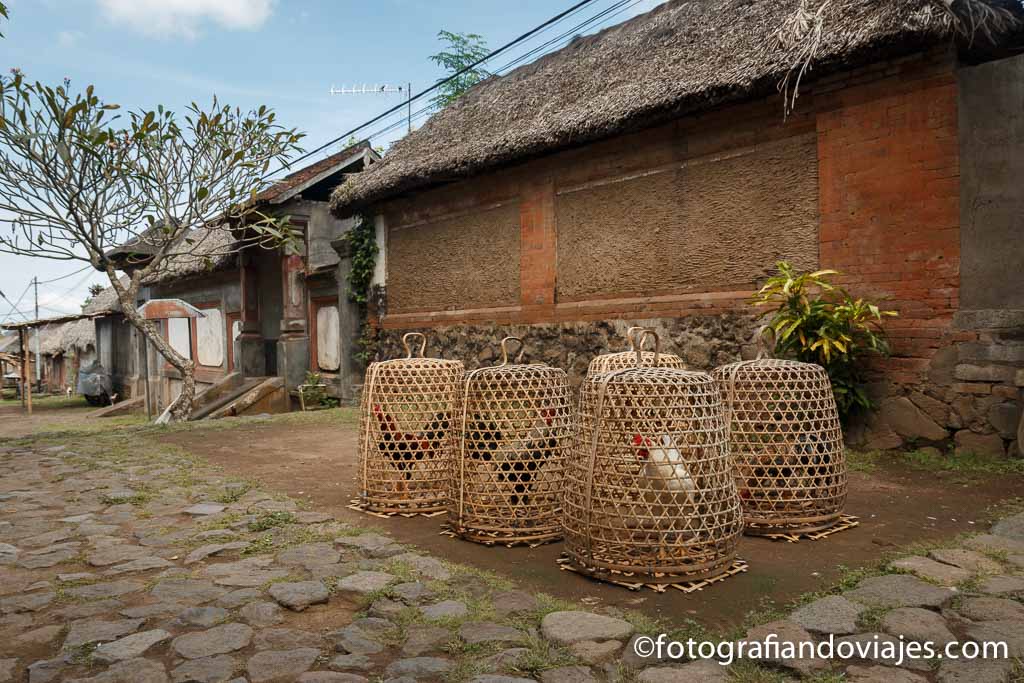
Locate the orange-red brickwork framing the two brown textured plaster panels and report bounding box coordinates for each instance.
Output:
[366,51,1019,453]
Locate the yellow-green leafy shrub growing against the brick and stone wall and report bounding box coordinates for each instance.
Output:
[754,261,898,420]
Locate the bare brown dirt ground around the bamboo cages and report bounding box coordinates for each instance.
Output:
[163,420,1024,627]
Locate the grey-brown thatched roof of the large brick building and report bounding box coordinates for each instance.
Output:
[331,0,1020,217]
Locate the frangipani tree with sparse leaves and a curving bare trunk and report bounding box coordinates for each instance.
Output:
[0,71,302,421]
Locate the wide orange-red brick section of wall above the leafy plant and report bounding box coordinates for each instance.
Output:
[817,71,959,384]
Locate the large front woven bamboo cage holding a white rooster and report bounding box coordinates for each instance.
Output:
[563,331,742,585]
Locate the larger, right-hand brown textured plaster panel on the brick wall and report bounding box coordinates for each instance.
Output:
[555,135,818,300]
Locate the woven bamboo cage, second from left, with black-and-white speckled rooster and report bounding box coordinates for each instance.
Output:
[449,337,572,546]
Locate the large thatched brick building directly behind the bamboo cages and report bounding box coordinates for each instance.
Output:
[332,0,1024,455]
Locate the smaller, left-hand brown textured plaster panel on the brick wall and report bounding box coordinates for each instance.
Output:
[387,202,520,312]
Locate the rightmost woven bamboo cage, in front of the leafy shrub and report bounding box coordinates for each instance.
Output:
[714,358,847,537]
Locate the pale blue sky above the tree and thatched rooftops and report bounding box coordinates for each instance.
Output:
[0,0,660,321]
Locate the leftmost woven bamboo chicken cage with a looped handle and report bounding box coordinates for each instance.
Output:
[359,332,465,514]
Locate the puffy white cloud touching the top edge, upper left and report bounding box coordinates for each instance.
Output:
[98,0,272,39]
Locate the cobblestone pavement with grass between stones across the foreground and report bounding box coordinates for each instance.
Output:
[0,431,1024,683]
